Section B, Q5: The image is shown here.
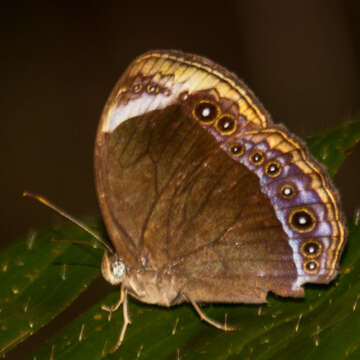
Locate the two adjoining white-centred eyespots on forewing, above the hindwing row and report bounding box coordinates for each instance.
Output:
[192,100,237,135]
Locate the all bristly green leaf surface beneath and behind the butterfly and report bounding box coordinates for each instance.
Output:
[0,122,360,360]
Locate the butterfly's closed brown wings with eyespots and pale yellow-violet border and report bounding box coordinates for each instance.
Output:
[95,51,345,302]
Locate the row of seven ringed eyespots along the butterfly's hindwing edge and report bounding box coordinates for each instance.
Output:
[228,143,322,274]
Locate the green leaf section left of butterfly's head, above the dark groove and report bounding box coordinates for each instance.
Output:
[0,219,102,354]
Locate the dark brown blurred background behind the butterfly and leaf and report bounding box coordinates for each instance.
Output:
[0,0,360,359]
